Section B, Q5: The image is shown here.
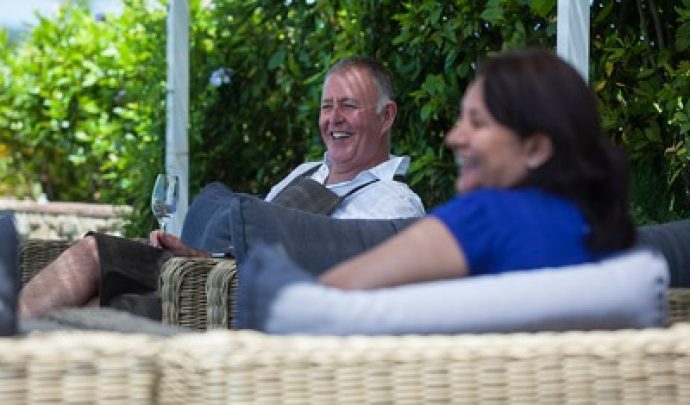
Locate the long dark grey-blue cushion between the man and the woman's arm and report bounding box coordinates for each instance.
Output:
[230,194,417,275]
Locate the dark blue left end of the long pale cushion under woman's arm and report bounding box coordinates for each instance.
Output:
[232,242,315,330]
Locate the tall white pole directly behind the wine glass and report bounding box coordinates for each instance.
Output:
[165,0,189,236]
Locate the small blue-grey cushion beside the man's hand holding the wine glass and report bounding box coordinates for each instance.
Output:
[181,182,236,252]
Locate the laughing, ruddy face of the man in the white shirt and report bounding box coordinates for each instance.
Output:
[319,68,395,177]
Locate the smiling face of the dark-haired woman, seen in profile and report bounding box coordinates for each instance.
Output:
[446,79,529,193]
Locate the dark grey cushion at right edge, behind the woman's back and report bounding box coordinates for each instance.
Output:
[638,220,690,288]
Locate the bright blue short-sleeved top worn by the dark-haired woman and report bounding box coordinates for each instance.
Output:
[430,189,594,275]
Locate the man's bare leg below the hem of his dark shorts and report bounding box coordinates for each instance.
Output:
[19,235,101,317]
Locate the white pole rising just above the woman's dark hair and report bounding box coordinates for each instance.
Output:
[556,0,590,80]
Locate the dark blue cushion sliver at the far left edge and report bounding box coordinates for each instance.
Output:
[0,213,19,336]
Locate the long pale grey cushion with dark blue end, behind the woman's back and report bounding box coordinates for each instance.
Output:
[236,246,668,335]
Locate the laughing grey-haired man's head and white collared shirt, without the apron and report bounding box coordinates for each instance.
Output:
[266,57,424,219]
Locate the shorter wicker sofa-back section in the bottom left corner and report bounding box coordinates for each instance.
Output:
[0,332,160,404]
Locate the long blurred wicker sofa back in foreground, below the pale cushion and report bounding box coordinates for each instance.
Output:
[160,324,690,404]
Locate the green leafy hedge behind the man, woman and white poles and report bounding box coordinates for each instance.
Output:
[0,0,690,235]
